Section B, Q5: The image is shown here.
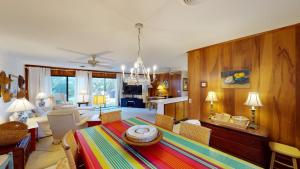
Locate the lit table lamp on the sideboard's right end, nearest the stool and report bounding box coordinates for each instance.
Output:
[245,92,263,129]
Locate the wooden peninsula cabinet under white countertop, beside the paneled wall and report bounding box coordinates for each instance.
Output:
[164,101,188,121]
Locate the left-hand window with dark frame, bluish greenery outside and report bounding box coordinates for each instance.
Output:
[51,76,75,104]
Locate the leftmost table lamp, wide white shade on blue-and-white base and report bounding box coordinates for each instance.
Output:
[6,98,35,123]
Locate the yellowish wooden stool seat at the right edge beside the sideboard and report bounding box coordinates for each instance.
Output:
[269,142,300,158]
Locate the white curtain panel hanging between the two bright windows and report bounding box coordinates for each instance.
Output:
[75,71,93,103]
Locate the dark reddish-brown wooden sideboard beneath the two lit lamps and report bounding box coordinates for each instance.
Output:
[201,121,270,168]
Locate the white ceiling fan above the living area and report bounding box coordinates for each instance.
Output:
[59,48,113,69]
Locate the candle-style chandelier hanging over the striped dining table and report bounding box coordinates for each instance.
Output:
[121,23,157,86]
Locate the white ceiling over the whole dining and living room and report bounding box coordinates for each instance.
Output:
[0,0,300,70]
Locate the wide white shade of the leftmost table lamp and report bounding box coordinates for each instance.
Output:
[6,98,35,113]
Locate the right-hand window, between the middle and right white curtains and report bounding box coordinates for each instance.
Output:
[93,78,117,106]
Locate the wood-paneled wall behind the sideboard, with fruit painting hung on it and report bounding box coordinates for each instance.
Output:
[188,24,300,148]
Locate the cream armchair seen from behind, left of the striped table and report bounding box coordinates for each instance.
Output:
[47,109,87,144]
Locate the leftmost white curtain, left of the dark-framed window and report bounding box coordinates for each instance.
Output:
[28,67,52,106]
